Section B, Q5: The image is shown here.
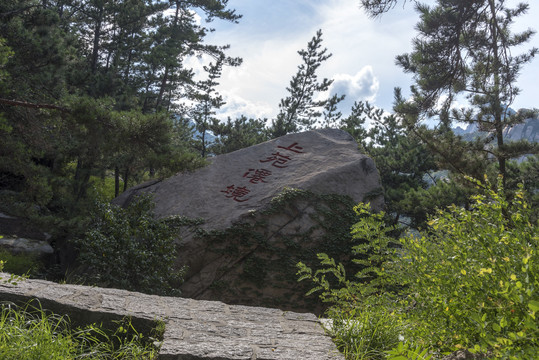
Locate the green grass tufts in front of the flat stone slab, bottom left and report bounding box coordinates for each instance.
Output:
[0,303,162,360]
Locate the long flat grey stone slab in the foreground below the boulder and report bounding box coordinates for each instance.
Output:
[0,273,344,360]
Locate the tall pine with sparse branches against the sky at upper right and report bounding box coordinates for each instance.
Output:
[362,0,538,184]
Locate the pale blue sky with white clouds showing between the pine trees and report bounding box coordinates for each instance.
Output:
[196,0,539,119]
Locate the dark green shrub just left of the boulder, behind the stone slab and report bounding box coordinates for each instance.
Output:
[75,197,184,294]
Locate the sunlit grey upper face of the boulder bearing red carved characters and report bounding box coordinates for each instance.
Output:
[113,129,382,229]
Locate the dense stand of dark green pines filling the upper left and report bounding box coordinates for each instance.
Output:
[0,0,240,216]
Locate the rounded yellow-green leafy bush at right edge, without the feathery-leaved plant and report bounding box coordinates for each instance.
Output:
[393,176,539,359]
